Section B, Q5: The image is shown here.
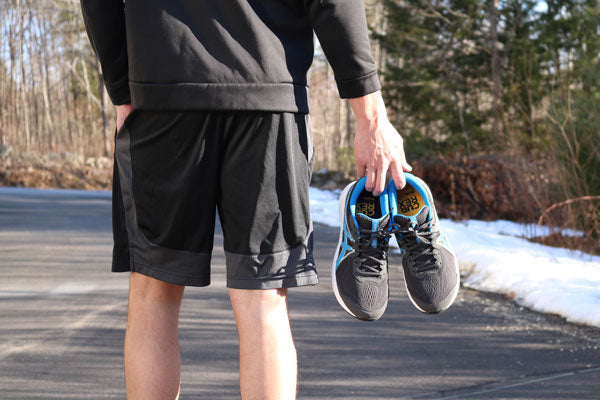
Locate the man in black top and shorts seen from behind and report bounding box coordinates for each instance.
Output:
[81,0,410,400]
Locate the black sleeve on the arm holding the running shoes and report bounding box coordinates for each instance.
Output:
[304,0,381,99]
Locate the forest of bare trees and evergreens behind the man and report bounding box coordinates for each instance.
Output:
[0,0,600,253]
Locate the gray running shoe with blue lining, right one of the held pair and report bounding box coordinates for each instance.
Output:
[387,173,460,314]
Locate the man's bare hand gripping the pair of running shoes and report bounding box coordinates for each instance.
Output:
[350,92,412,196]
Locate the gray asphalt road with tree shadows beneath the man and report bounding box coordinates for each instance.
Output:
[0,189,600,400]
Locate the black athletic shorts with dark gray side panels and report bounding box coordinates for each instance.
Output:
[112,110,317,289]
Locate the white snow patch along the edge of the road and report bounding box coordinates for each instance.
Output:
[310,188,600,327]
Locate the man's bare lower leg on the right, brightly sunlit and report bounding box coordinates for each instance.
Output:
[229,289,297,400]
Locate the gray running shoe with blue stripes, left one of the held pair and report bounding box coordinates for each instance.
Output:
[331,178,391,321]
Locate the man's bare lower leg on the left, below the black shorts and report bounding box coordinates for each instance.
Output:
[125,272,184,400]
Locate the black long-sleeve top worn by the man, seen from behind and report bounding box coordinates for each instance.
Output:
[81,0,381,113]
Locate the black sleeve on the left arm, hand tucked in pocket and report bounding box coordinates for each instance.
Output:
[80,0,131,105]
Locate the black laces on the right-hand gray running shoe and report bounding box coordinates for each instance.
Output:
[391,218,440,275]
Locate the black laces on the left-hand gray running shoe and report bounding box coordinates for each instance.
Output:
[351,224,390,277]
